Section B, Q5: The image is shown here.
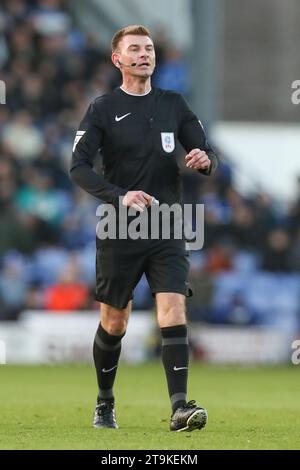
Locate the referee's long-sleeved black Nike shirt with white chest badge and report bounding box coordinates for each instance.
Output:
[71,88,217,205]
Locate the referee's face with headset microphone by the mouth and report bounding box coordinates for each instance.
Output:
[117,34,155,78]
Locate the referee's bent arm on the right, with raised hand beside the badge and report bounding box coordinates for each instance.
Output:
[178,95,218,176]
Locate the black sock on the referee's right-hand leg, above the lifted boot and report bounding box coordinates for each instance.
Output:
[161,325,189,412]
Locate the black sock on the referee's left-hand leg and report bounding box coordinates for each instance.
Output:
[93,323,125,401]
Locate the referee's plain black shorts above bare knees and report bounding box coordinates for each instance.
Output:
[95,239,192,308]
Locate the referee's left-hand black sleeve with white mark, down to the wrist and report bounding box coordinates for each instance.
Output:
[70,102,127,206]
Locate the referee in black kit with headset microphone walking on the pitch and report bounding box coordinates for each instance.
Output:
[70,25,217,431]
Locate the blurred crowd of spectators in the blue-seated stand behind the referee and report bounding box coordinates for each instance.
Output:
[0,0,300,330]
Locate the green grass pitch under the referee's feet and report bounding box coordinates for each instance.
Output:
[0,363,300,450]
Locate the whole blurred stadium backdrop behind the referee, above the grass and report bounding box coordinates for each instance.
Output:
[0,0,300,363]
